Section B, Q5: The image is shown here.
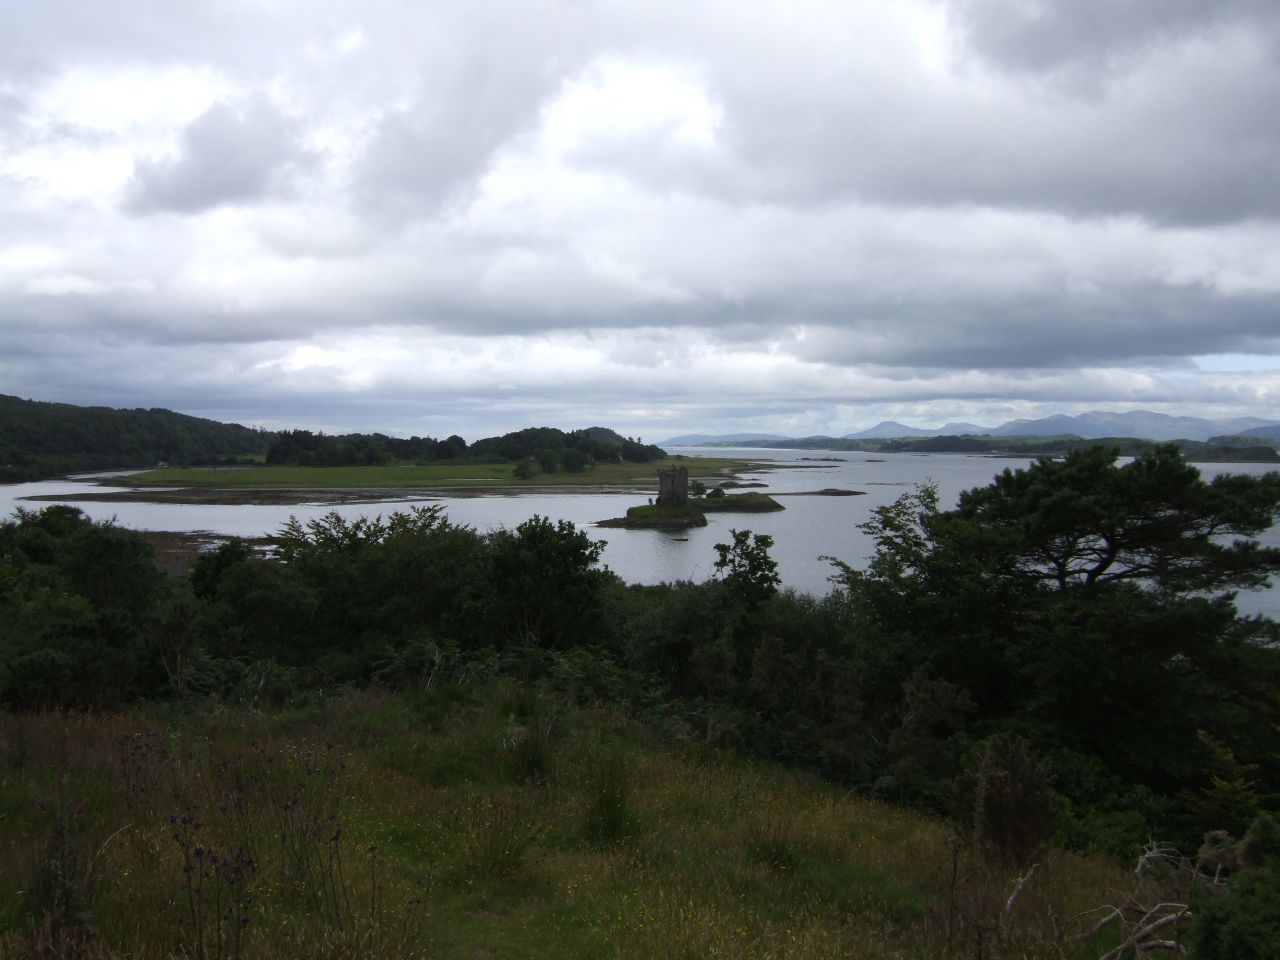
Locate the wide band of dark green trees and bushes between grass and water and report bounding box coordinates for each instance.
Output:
[0,434,1280,890]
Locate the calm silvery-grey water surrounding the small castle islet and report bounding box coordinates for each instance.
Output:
[0,448,1280,618]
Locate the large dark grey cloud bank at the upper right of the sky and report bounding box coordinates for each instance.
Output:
[580,0,1280,224]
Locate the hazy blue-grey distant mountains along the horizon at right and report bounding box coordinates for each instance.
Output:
[659,410,1280,447]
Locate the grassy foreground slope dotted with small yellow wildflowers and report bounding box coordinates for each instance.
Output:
[0,681,1132,960]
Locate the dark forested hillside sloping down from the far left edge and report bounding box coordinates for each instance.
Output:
[0,396,274,483]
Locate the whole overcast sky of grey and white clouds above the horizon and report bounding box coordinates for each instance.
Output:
[0,0,1280,440]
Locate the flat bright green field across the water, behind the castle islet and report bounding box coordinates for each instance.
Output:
[128,457,744,489]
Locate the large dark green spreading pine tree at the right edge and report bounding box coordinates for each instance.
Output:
[833,445,1280,846]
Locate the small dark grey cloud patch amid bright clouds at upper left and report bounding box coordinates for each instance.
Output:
[127,97,303,214]
